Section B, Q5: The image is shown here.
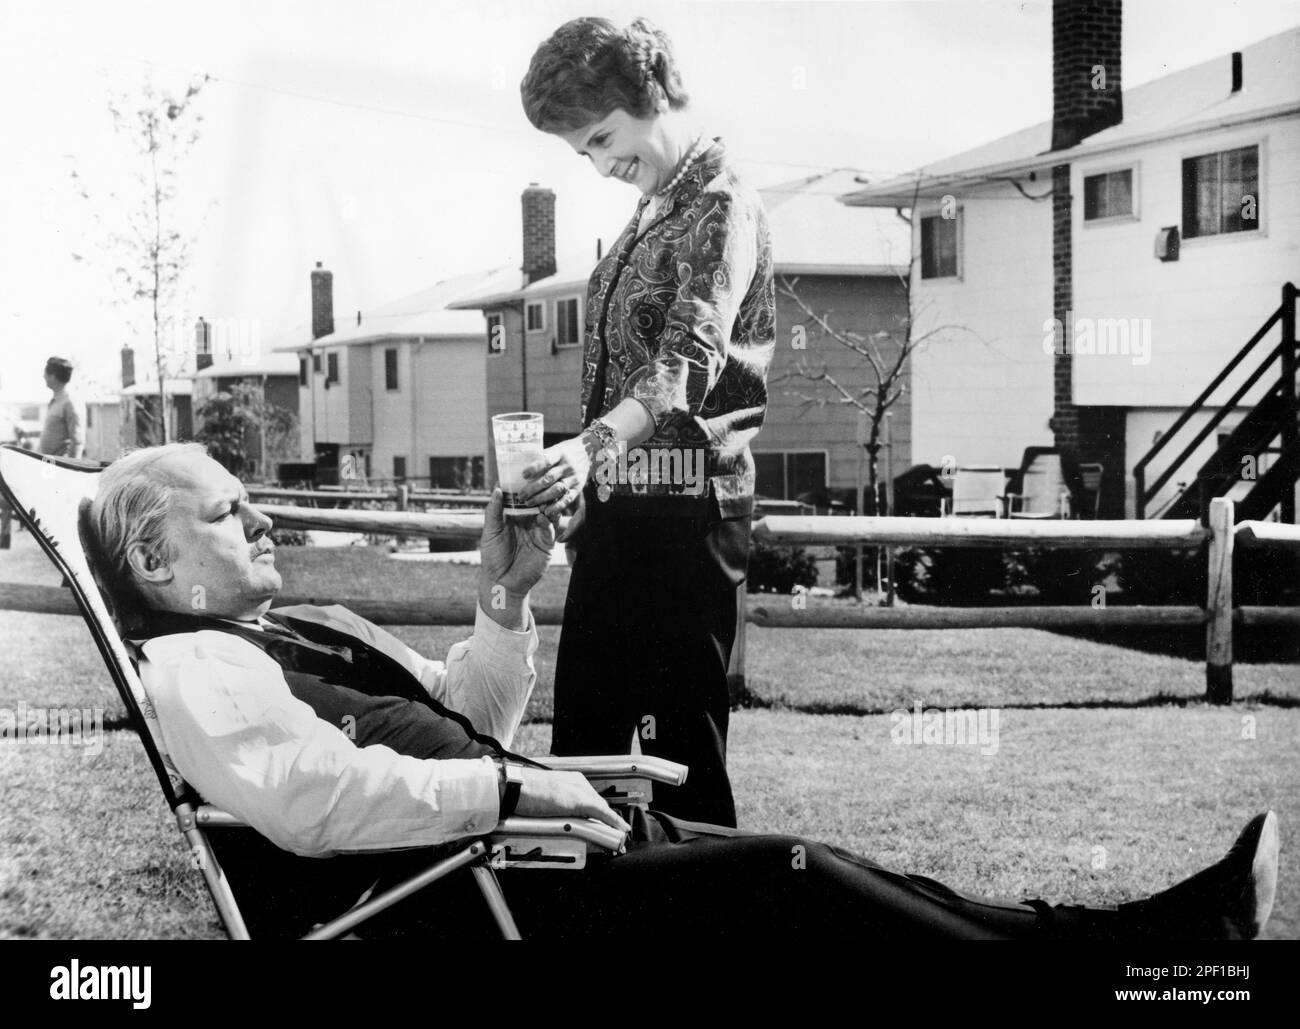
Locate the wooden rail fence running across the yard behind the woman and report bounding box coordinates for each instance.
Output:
[0,490,1300,703]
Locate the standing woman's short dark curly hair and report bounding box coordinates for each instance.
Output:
[519,18,690,133]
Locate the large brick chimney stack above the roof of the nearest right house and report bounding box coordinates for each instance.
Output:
[1052,0,1125,151]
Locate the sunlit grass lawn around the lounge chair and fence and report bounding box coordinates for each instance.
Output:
[0,534,1300,938]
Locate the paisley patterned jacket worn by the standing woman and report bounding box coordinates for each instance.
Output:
[582,136,776,517]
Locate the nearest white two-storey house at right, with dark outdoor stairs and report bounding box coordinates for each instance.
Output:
[841,0,1300,521]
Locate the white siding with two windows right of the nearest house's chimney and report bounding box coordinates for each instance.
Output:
[1071,117,1300,407]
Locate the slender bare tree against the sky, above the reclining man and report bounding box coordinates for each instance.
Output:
[72,75,209,443]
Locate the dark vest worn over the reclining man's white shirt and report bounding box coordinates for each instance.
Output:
[131,612,536,764]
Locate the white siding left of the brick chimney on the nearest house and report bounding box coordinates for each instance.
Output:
[911,182,1052,466]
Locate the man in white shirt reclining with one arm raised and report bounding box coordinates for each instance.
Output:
[81,444,1278,941]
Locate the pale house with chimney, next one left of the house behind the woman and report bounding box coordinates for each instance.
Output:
[270,262,519,489]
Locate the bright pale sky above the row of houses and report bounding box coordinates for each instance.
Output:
[0,0,1300,399]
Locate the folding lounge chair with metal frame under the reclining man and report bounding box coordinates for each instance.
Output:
[0,446,686,939]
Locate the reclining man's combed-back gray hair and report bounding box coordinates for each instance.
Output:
[86,443,208,629]
